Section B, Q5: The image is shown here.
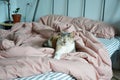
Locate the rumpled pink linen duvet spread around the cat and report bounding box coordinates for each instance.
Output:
[0,15,112,80]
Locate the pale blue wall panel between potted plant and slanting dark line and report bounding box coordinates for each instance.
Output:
[17,0,36,22]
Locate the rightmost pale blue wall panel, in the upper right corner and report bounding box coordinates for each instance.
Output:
[104,0,120,24]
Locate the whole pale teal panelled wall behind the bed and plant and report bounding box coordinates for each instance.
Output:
[0,0,120,25]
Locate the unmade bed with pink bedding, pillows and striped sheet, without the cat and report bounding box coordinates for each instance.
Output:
[0,15,119,80]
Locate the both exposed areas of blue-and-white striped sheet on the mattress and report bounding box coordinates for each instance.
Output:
[14,37,120,80]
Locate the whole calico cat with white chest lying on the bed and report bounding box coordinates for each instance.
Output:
[43,32,75,59]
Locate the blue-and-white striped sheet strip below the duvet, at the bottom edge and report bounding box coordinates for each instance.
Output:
[14,72,75,80]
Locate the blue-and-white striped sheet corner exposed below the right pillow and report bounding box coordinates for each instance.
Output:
[98,37,120,57]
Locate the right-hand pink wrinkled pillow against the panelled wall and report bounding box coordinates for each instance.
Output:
[71,17,115,38]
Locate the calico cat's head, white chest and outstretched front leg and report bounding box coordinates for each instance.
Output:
[54,33,75,59]
